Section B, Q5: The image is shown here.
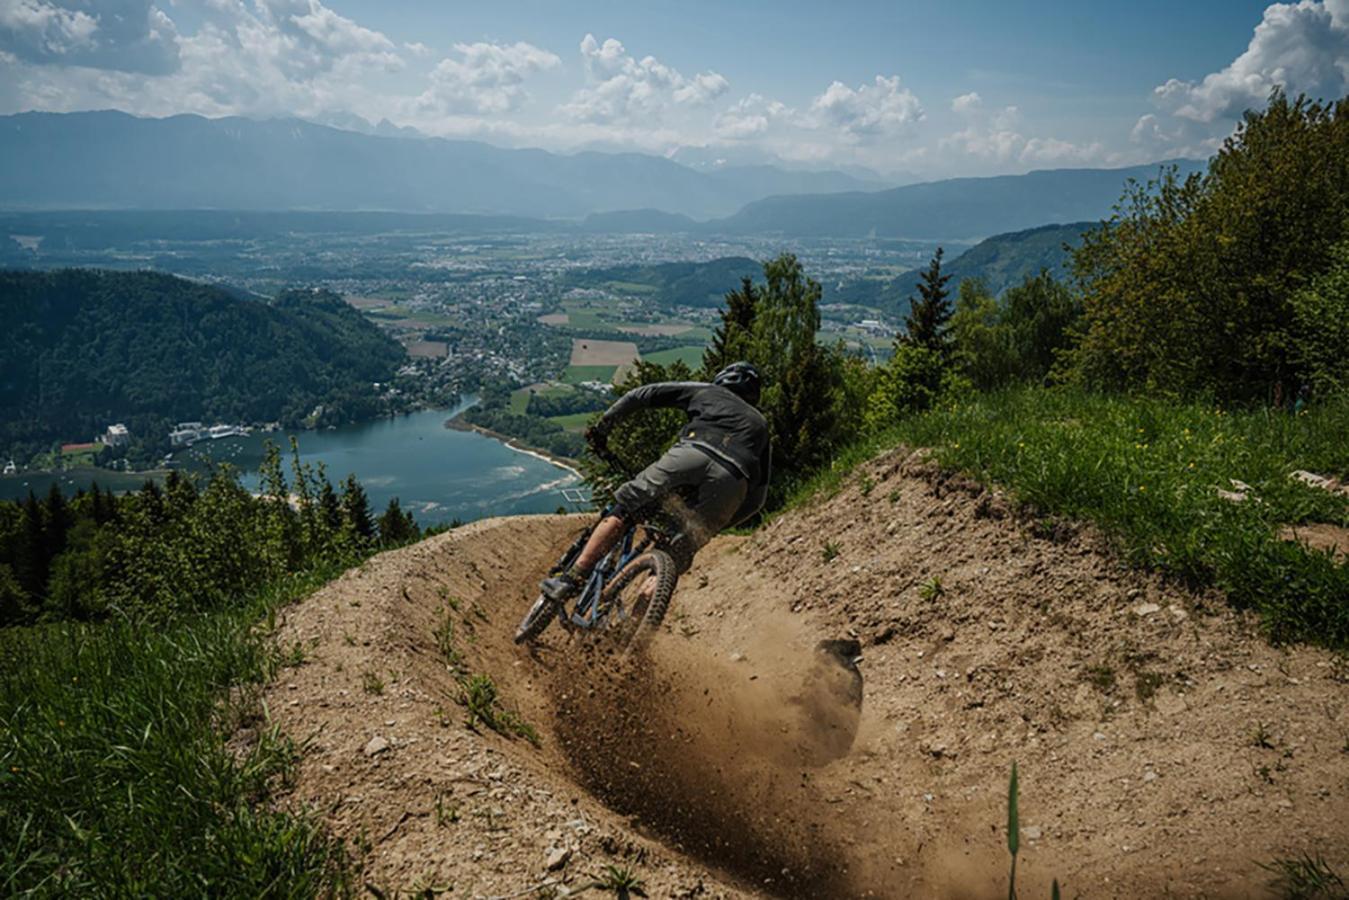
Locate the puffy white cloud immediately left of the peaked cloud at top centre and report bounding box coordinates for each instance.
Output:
[414,42,563,115]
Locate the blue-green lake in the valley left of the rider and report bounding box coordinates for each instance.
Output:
[0,398,581,525]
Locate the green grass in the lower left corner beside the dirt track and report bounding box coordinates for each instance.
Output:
[0,565,348,896]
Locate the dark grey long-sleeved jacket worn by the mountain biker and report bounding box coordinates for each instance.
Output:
[599,382,772,522]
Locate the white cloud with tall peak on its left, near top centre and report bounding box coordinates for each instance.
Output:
[561,34,730,125]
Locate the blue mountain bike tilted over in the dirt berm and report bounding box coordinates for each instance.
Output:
[515,448,689,652]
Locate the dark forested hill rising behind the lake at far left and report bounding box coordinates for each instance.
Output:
[0,270,403,456]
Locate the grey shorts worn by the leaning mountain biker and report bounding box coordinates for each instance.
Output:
[614,444,749,558]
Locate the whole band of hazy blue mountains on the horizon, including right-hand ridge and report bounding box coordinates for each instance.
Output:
[0,112,1205,242]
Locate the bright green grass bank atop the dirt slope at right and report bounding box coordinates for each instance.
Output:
[788,389,1349,649]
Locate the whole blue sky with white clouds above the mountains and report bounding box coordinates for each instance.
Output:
[0,0,1349,177]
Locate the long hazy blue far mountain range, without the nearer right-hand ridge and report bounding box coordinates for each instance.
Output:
[0,111,870,219]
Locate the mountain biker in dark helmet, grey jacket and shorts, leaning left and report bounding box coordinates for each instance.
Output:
[540,362,772,603]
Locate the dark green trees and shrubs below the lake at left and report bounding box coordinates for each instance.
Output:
[0,444,421,625]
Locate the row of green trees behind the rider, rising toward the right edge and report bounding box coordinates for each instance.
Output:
[594,92,1349,503]
